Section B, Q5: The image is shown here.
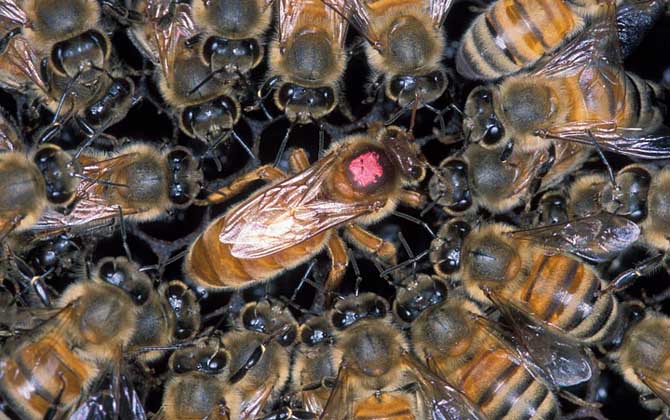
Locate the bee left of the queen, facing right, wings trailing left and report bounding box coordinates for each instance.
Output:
[31,144,202,234]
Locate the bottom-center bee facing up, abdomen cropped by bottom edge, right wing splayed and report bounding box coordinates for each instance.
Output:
[319,293,485,420]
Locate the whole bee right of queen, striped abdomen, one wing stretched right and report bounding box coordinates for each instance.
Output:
[430,214,640,354]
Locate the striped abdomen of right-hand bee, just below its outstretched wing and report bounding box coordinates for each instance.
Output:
[516,253,618,344]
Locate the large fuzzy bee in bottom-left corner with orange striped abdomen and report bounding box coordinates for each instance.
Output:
[0,259,151,420]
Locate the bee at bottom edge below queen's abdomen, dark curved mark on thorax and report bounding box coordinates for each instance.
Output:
[223,301,298,420]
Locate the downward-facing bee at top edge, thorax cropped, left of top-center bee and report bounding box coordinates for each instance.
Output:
[192,0,273,81]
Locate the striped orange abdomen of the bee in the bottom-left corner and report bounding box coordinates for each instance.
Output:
[0,335,97,420]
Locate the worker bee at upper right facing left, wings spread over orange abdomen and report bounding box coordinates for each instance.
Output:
[464,0,670,159]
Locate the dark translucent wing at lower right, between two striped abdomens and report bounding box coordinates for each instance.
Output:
[484,288,593,387]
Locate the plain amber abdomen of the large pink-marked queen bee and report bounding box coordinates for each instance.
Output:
[185,215,331,288]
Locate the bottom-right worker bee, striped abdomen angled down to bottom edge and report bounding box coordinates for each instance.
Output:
[394,275,561,420]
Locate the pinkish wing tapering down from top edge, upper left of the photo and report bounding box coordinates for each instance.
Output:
[146,0,197,85]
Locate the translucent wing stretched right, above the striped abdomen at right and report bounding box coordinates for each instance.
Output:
[507,212,640,262]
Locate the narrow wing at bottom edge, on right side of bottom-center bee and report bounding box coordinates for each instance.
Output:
[402,352,486,420]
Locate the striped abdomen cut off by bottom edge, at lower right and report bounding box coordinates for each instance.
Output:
[445,338,560,420]
